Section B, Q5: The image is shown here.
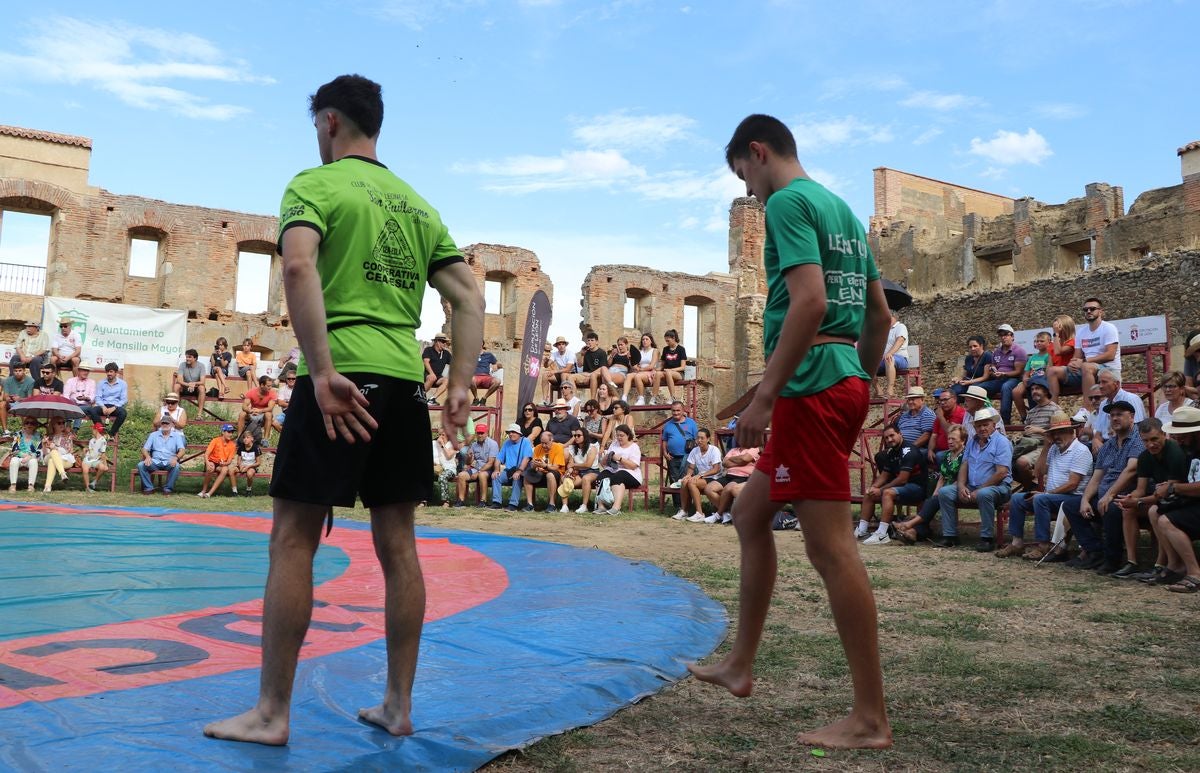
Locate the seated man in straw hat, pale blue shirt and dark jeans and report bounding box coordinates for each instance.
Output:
[996,412,1092,561]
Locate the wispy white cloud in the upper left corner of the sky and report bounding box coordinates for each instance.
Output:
[0,17,274,120]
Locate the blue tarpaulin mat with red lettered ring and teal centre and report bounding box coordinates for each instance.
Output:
[0,504,726,771]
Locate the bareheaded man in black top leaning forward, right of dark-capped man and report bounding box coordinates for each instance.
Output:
[1111,417,1189,580]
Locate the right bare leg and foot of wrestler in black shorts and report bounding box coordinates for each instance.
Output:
[359,503,425,736]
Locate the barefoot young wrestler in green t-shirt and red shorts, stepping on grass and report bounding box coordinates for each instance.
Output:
[689,115,892,749]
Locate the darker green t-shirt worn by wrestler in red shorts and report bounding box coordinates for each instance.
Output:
[762,178,880,397]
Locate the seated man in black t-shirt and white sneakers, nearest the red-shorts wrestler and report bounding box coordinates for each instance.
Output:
[854,424,929,545]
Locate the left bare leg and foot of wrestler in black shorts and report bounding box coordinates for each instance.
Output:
[204,499,326,745]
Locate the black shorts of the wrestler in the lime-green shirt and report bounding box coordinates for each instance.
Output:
[270,373,433,508]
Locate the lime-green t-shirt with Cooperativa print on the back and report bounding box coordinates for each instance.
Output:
[280,156,462,382]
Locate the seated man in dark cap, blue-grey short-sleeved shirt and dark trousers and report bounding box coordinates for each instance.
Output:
[1063,400,1146,574]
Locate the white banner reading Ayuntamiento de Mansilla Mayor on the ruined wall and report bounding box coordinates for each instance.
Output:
[42,295,187,370]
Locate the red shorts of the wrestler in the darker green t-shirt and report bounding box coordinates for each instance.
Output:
[755,376,868,502]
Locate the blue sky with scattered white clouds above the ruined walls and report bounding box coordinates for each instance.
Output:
[0,0,1200,340]
